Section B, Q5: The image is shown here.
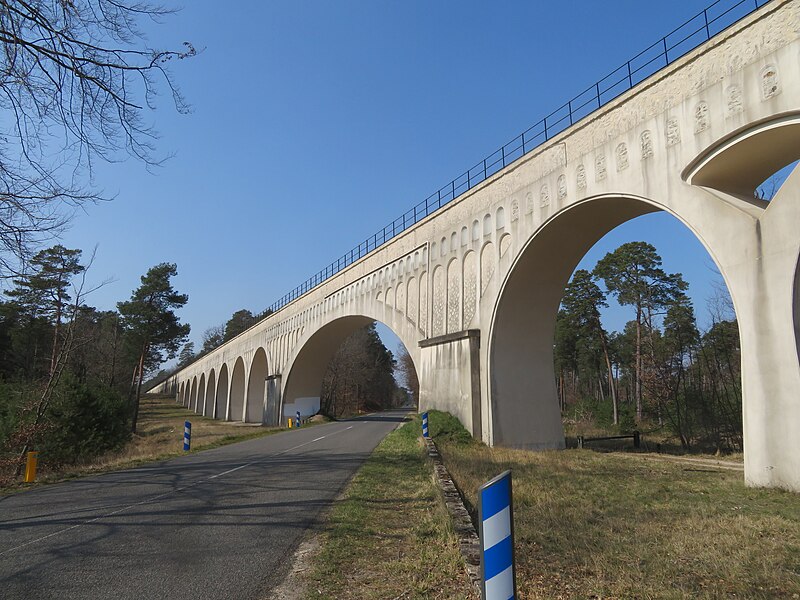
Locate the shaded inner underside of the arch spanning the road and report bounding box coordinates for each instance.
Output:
[280,314,419,420]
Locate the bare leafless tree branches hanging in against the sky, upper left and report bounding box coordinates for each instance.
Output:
[0,0,196,278]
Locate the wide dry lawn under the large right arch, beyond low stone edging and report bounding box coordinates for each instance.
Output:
[430,411,800,598]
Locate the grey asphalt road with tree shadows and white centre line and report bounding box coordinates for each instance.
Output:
[0,411,405,600]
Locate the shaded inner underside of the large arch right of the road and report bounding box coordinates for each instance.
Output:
[488,194,741,449]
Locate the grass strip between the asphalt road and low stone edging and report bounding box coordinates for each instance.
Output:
[303,421,473,600]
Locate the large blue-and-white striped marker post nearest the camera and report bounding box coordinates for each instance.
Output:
[478,471,517,600]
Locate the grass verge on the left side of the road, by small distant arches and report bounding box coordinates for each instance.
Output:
[0,396,283,494]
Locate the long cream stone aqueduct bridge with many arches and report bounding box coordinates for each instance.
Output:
[152,0,800,491]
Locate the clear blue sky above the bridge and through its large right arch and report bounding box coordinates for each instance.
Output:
[53,0,780,360]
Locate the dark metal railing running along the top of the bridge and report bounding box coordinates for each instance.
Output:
[268,0,771,312]
